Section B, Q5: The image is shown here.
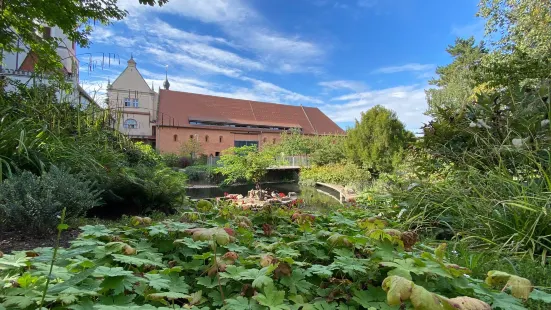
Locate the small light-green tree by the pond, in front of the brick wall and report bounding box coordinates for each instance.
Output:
[216,145,275,197]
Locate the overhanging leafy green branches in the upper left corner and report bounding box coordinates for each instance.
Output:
[0,0,168,78]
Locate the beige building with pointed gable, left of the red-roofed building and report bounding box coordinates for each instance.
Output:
[107,57,158,145]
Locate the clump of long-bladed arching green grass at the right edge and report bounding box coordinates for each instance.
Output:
[394,168,551,254]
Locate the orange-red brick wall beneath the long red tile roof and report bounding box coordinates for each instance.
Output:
[156,127,280,156]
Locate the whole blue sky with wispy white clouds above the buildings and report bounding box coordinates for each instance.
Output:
[77,0,483,132]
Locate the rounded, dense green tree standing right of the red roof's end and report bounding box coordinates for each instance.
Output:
[345,105,414,176]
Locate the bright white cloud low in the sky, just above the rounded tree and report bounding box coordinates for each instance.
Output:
[321,85,429,132]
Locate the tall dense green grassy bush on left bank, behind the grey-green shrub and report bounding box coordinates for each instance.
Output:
[0,81,185,217]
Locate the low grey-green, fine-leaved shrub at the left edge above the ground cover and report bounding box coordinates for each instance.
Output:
[0,167,100,233]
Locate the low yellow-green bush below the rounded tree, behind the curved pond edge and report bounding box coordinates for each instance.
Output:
[300,162,371,188]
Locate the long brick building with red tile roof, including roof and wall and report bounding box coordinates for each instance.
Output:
[156,87,345,156]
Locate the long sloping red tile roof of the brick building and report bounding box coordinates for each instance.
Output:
[157,89,345,134]
